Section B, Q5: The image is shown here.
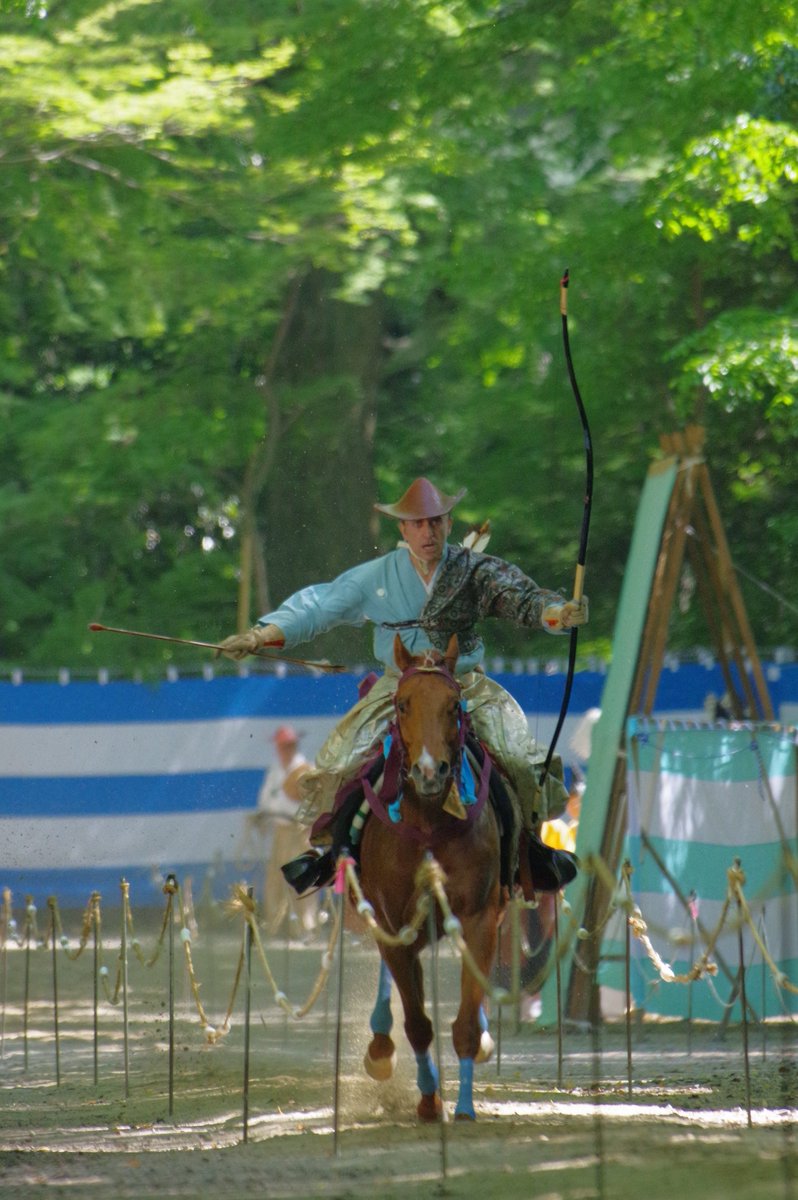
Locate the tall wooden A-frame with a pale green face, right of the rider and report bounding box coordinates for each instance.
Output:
[544,426,774,1022]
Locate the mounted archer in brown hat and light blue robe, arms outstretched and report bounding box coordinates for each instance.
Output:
[221,479,588,890]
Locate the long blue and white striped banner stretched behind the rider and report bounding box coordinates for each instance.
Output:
[0,672,604,906]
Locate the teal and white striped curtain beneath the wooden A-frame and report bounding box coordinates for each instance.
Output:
[601,718,798,1020]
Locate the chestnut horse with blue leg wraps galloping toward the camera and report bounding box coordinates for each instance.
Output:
[360,635,505,1121]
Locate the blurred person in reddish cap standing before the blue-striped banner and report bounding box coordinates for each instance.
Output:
[250,725,316,936]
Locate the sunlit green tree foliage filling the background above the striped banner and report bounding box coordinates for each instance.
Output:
[0,0,798,670]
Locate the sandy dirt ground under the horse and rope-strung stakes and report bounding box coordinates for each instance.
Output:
[0,907,798,1200]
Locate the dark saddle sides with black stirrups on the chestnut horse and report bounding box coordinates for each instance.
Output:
[281,734,578,899]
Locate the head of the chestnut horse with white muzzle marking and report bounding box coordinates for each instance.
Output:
[394,634,460,799]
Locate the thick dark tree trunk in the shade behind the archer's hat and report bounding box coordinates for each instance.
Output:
[259,272,383,661]
